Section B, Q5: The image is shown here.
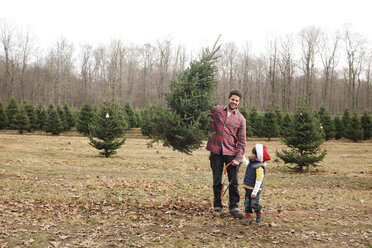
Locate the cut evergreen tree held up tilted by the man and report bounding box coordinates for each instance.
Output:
[150,41,220,154]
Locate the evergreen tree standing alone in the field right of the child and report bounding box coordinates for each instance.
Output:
[276,101,326,172]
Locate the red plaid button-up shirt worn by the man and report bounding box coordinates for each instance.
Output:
[207,105,246,162]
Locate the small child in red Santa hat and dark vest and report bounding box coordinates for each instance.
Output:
[243,144,271,225]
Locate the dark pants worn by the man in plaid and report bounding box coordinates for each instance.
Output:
[209,153,240,211]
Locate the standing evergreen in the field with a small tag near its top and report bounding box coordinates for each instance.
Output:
[88,101,128,158]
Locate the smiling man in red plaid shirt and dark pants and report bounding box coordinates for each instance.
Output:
[207,90,246,219]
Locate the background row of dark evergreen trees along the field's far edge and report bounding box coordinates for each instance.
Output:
[0,98,372,142]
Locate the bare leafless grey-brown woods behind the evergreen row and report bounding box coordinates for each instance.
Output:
[0,21,372,114]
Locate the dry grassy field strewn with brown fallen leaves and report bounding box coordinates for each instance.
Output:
[0,132,372,247]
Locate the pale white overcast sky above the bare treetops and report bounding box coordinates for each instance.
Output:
[0,0,372,52]
